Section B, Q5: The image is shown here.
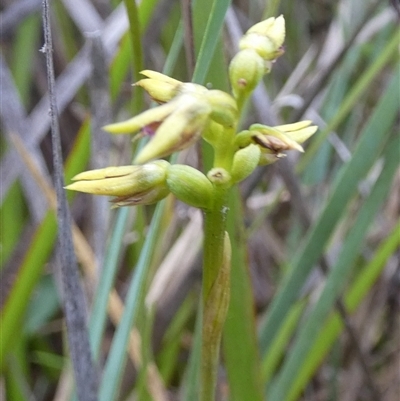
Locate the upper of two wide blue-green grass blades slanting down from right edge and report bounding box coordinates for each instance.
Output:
[260,71,400,354]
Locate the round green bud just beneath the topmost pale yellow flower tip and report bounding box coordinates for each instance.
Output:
[229,49,266,97]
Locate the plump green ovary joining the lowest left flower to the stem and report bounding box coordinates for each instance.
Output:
[167,164,213,209]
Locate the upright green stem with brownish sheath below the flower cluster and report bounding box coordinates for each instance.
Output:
[200,187,230,401]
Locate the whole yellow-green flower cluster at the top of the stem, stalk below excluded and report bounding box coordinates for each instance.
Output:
[66,16,317,209]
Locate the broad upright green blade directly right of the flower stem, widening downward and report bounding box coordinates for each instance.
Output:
[222,190,263,401]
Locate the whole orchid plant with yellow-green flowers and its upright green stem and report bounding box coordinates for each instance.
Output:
[66,16,317,401]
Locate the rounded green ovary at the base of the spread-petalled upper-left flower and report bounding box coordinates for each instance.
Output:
[204,89,238,127]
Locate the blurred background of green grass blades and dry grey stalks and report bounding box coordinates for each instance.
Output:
[0,0,400,401]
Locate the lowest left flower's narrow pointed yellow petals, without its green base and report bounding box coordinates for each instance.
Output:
[65,160,169,206]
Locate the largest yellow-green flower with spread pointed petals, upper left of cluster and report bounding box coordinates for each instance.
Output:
[104,71,238,164]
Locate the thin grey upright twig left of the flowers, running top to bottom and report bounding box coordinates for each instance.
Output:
[42,0,98,401]
